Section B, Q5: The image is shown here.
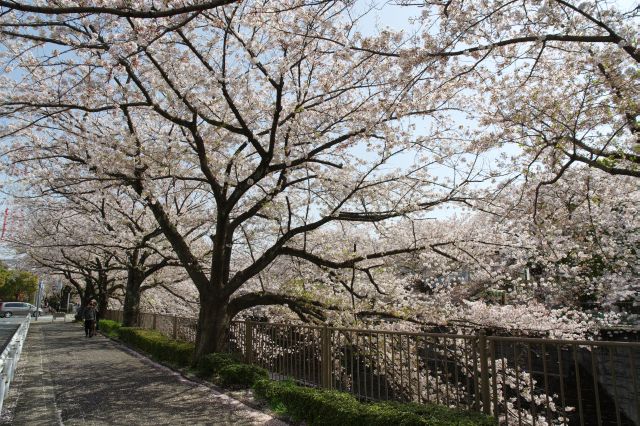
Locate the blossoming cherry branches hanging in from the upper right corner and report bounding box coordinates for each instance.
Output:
[400,0,640,184]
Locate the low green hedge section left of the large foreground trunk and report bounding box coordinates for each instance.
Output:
[119,327,194,367]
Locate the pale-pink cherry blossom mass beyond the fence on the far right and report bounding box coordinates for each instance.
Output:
[384,168,640,338]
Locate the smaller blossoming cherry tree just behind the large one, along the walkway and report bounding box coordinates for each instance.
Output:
[3,179,206,326]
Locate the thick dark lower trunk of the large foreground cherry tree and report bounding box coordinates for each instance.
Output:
[193,296,231,364]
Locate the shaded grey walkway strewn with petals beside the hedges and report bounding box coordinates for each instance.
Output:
[2,322,283,426]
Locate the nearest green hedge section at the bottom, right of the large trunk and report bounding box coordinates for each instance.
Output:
[254,380,496,426]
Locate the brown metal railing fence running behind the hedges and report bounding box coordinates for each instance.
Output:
[102,314,640,425]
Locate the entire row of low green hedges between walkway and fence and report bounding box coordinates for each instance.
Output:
[100,320,496,426]
